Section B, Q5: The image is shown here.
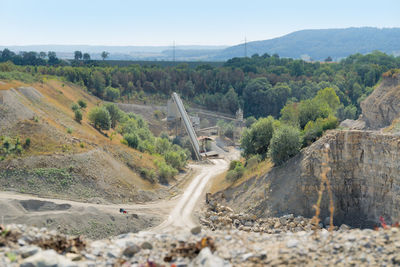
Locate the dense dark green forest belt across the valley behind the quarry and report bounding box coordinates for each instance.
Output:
[0,49,400,119]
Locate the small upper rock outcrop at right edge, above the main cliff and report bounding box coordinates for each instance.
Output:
[361,74,400,129]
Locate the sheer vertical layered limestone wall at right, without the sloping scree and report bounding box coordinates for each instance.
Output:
[300,131,400,226]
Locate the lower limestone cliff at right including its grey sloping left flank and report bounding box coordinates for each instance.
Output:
[219,131,400,227]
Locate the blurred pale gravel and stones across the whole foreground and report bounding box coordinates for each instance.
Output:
[0,225,400,267]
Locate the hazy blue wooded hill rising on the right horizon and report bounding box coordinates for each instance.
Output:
[214,27,400,60]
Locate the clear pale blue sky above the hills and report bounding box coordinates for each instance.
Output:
[0,0,400,45]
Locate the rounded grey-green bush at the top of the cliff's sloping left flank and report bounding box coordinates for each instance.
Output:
[268,125,301,165]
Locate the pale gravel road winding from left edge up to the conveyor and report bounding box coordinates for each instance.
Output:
[0,159,228,236]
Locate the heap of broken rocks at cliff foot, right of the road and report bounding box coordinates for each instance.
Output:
[199,202,326,234]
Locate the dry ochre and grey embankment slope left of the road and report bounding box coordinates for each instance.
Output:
[0,80,180,203]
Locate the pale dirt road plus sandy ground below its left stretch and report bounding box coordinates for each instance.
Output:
[0,159,228,239]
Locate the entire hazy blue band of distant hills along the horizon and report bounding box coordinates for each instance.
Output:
[0,27,400,61]
